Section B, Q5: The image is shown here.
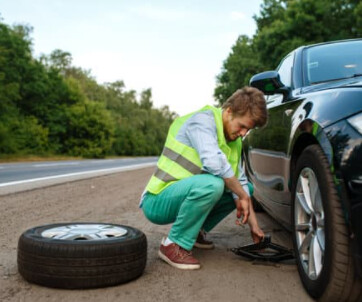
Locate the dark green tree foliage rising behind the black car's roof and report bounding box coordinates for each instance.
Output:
[214,0,362,104]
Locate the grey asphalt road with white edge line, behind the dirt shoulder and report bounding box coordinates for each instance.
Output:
[0,157,157,195]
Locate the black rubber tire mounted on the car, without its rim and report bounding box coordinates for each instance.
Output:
[291,145,362,302]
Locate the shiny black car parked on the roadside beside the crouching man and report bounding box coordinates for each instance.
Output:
[243,39,362,302]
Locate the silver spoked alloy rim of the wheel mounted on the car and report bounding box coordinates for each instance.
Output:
[294,167,325,280]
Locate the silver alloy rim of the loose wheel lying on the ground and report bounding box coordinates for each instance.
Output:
[41,224,127,240]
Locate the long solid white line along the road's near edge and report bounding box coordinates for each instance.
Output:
[0,162,156,187]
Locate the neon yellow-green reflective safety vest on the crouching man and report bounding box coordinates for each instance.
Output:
[146,105,242,194]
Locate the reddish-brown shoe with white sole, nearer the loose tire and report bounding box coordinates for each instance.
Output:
[158,240,201,269]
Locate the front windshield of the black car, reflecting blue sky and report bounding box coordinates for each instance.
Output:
[304,40,362,85]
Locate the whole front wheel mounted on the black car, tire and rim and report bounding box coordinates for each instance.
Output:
[292,145,361,302]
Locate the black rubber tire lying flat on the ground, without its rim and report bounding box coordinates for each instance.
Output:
[17,223,147,289]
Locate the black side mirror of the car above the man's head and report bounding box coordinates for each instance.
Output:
[250,70,285,95]
